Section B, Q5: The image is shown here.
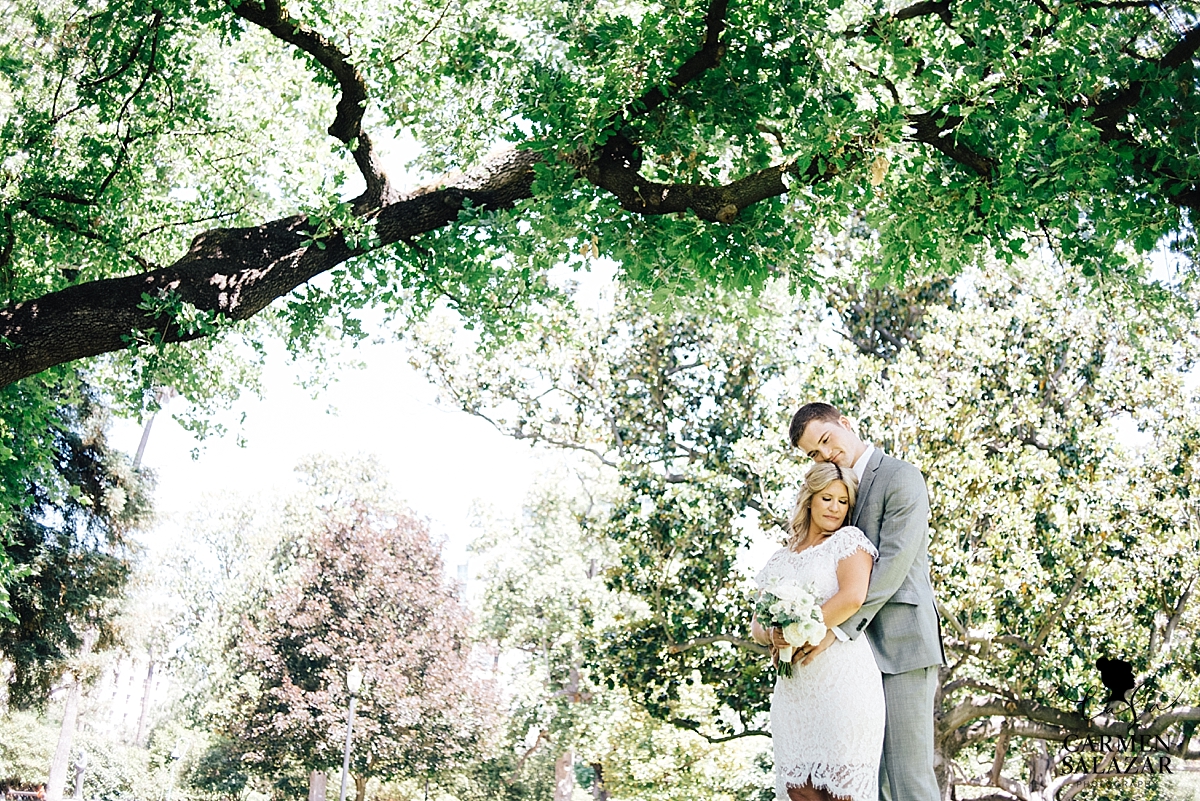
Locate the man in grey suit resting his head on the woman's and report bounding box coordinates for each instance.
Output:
[790,403,946,801]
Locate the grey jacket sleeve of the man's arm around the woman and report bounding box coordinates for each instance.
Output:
[841,464,929,638]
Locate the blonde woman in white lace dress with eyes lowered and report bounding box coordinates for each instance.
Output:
[751,462,884,801]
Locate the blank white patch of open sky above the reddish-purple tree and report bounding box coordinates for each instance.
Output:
[110,335,539,574]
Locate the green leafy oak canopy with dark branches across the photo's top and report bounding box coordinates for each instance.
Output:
[0,0,1200,384]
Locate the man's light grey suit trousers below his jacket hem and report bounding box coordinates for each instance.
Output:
[880,667,941,801]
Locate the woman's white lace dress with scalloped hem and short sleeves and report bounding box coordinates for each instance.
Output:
[755,526,884,801]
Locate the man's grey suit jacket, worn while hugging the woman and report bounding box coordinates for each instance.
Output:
[841,448,946,674]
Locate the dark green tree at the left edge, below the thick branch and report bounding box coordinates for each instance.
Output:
[0,372,151,706]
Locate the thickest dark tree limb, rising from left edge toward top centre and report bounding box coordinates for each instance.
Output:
[0,151,538,386]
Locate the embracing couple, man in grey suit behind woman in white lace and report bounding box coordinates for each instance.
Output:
[752,403,944,801]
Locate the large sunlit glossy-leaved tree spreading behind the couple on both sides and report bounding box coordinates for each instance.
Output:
[410,257,1200,799]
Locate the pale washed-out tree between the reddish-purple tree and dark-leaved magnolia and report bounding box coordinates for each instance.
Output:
[448,484,774,801]
